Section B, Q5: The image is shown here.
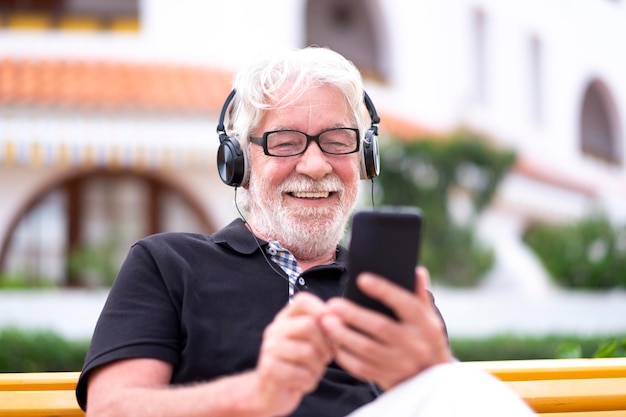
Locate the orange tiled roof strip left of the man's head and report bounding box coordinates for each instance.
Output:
[0,58,232,112]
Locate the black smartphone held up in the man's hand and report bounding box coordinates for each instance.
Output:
[344,207,422,319]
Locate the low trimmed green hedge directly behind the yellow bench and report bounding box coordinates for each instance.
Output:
[0,328,626,372]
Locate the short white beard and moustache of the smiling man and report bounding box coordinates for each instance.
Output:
[248,175,358,260]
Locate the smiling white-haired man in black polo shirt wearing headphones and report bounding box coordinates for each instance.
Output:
[77,48,529,417]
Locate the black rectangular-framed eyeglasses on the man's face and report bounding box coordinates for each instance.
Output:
[250,127,360,157]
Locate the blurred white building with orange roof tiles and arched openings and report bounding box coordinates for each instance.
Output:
[0,0,626,285]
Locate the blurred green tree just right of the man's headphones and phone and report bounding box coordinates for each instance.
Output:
[376,131,515,286]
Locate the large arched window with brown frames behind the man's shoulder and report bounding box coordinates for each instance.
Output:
[0,170,211,286]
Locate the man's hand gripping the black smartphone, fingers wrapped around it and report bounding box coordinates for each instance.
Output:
[322,267,452,390]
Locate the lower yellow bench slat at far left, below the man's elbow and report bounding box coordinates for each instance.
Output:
[0,390,85,417]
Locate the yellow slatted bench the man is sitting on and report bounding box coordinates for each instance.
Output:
[0,358,626,417]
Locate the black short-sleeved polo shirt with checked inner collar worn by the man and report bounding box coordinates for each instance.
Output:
[76,220,374,417]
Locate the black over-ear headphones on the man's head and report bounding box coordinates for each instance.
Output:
[217,90,380,187]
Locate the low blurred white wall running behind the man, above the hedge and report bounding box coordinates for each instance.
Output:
[0,288,626,339]
